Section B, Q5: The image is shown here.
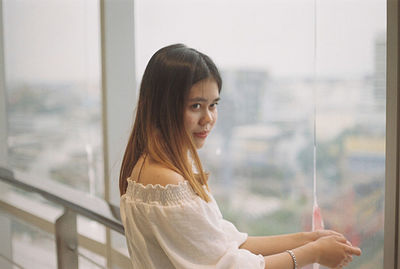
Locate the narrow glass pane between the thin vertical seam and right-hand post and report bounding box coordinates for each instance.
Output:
[316,0,386,269]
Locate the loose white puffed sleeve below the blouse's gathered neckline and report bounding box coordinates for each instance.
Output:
[147,197,265,269]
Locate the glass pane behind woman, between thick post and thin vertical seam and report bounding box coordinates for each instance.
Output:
[135,0,314,230]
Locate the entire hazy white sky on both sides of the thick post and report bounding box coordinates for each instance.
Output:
[3,0,386,81]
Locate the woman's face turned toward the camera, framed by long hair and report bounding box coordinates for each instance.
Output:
[184,79,219,149]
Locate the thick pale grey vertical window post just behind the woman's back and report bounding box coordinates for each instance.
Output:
[100,0,136,268]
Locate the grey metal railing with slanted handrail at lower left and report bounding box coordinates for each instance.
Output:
[0,167,131,269]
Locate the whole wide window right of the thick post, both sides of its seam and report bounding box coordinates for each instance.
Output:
[135,0,386,268]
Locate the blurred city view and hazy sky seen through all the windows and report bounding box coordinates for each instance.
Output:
[0,0,386,269]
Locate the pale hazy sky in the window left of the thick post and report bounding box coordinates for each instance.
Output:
[3,0,100,82]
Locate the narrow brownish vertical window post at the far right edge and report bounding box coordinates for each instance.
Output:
[384,0,400,269]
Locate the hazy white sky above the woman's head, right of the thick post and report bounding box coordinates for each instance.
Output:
[135,0,386,79]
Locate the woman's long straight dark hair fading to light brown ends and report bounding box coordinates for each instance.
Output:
[119,44,222,201]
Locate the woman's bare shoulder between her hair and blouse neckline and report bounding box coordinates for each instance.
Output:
[134,160,185,186]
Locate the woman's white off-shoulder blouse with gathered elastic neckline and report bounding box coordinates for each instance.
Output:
[120,179,264,269]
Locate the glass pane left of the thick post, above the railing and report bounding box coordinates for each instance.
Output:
[3,0,104,196]
